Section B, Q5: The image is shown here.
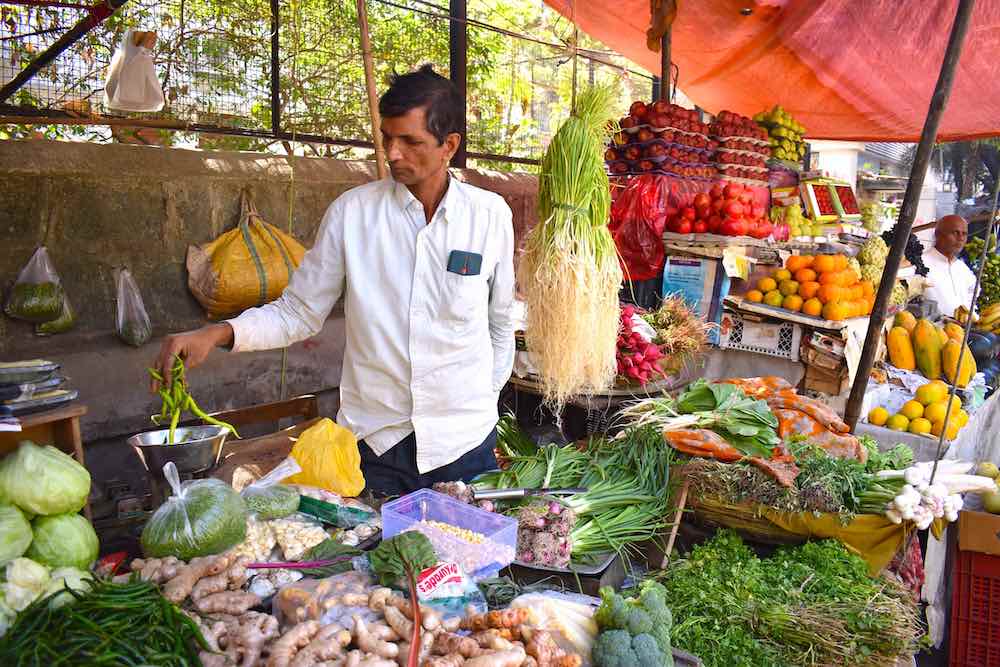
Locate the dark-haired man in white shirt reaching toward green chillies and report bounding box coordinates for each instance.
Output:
[156,66,514,495]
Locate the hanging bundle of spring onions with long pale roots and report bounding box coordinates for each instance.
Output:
[518,86,622,414]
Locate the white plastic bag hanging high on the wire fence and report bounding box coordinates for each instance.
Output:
[104,30,164,112]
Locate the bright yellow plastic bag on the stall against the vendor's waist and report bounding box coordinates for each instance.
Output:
[282,419,365,498]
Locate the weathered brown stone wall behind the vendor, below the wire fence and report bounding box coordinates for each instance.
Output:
[0,141,537,494]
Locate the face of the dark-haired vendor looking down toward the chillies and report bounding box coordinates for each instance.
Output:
[382,107,461,185]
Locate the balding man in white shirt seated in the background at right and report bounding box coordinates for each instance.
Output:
[923,215,976,317]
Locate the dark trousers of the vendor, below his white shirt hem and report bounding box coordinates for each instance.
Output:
[358,429,497,496]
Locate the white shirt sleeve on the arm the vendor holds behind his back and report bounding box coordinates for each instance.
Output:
[489,204,514,392]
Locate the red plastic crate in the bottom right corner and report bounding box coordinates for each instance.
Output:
[948,550,1000,667]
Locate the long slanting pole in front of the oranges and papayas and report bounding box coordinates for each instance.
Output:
[844,0,976,431]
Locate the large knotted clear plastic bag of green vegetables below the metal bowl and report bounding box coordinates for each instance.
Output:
[141,462,247,560]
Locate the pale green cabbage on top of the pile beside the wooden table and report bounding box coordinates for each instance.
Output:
[0,440,90,515]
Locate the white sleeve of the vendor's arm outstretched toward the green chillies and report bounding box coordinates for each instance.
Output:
[228,201,345,352]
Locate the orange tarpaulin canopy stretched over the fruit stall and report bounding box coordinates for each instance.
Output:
[545,0,1000,142]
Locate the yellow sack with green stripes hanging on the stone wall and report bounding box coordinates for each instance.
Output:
[187,192,306,319]
